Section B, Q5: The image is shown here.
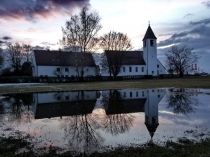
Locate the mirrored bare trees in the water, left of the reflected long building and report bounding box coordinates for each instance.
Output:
[1,94,34,124]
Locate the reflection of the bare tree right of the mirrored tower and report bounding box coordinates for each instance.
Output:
[167,88,199,114]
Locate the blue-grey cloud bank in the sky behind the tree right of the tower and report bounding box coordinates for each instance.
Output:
[158,25,210,71]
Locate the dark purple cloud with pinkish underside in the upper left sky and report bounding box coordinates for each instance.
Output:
[0,0,90,21]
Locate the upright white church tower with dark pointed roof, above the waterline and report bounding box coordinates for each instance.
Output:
[142,25,158,76]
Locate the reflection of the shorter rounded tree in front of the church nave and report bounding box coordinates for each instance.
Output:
[101,90,135,135]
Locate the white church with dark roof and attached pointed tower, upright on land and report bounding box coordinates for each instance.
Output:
[101,25,166,76]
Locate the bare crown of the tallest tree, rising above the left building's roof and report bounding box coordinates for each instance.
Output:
[61,7,102,52]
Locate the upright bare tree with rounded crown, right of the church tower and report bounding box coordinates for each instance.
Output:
[165,45,200,77]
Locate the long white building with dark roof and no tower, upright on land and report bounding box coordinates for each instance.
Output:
[32,50,98,77]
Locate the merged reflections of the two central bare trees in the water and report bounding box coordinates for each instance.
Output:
[60,90,134,153]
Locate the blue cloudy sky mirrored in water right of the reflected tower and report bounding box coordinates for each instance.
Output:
[158,89,210,127]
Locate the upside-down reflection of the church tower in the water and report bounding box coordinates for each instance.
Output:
[144,90,159,138]
